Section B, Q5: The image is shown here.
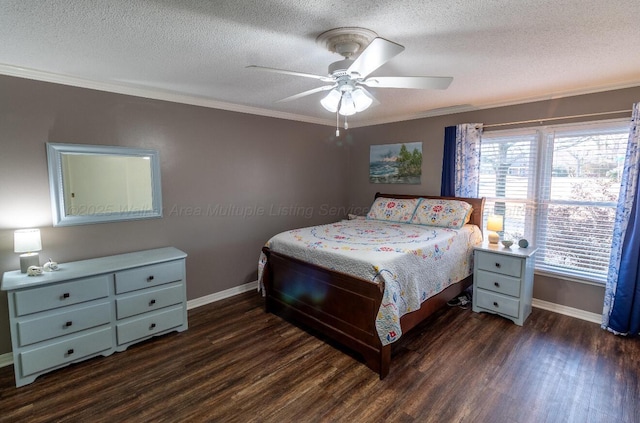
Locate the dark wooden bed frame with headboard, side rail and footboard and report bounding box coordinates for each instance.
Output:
[262,193,485,379]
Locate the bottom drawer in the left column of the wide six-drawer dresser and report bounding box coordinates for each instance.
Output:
[20,326,112,376]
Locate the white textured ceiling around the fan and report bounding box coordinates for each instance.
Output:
[0,0,640,126]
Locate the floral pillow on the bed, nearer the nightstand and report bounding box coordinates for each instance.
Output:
[411,198,473,229]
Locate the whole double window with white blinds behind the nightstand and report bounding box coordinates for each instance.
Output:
[479,120,629,282]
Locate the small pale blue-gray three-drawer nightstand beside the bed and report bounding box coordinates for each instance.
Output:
[473,243,537,326]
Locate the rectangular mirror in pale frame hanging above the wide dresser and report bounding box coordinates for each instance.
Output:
[47,143,162,226]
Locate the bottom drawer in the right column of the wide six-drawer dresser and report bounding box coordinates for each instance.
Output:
[116,306,184,345]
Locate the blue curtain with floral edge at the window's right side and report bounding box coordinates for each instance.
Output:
[602,103,640,335]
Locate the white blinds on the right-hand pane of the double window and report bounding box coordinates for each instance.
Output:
[536,125,629,279]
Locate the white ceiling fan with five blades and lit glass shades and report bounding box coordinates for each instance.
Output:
[247,27,453,116]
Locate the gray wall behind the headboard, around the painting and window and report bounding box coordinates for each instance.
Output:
[349,87,640,313]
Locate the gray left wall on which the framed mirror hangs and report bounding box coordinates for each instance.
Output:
[0,76,349,354]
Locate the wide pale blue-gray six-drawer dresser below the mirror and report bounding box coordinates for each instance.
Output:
[2,247,188,386]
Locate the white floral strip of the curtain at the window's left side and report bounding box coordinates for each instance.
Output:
[455,123,482,198]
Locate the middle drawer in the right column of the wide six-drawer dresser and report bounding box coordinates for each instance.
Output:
[116,282,185,319]
